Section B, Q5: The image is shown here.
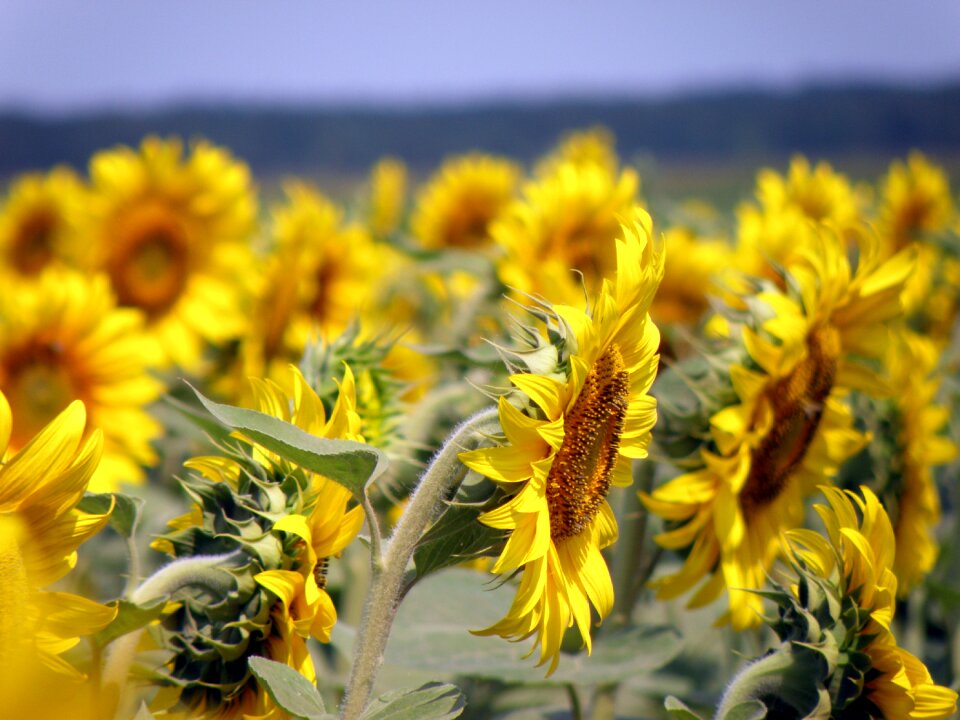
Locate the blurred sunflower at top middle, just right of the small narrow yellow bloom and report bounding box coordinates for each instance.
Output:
[410,153,520,250]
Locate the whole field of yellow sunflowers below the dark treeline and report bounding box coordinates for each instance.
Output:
[0,128,960,720]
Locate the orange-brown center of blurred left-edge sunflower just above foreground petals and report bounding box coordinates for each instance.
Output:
[0,342,78,448]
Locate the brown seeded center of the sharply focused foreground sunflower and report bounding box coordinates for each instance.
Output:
[546,344,630,541]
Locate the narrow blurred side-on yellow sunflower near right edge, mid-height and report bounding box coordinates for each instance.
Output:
[887,332,957,595]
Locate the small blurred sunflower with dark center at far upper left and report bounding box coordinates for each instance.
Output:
[0,167,84,276]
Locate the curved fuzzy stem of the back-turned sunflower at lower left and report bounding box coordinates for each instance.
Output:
[103,551,240,717]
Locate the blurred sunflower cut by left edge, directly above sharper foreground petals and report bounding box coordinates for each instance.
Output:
[0,269,163,492]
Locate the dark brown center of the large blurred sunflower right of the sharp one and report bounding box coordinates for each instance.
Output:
[740,325,841,512]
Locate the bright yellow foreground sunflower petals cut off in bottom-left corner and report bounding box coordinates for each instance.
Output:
[0,393,117,692]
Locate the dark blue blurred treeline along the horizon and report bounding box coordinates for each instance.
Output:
[0,83,960,174]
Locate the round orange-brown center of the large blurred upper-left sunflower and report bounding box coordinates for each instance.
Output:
[107,202,190,317]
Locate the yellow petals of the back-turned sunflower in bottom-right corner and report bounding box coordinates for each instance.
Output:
[775,487,957,718]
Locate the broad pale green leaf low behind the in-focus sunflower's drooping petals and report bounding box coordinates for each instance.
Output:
[386,568,682,686]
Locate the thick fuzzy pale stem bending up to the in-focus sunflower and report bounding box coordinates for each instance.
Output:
[341,408,497,720]
